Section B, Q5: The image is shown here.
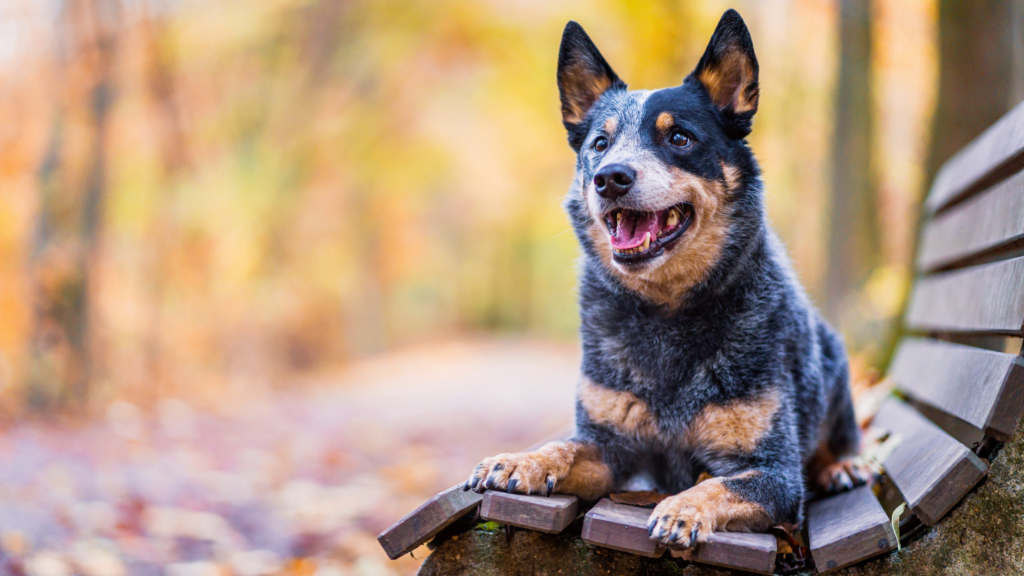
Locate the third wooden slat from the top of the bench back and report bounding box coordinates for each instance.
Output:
[906,257,1024,336]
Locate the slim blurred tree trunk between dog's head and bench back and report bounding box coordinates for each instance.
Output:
[824,0,881,325]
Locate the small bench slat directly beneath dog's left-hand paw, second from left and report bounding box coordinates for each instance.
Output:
[480,490,580,534]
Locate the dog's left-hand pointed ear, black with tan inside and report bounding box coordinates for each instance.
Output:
[558,22,626,152]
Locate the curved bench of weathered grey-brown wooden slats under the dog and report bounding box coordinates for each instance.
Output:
[379,98,1024,574]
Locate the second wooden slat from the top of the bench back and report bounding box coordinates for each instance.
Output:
[918,168,1024,272]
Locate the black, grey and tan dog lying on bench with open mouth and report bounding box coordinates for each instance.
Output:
[464,10,870,548]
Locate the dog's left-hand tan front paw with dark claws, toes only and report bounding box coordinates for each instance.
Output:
[463,452,568,496]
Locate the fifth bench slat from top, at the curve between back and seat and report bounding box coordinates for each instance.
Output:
[873,399,988,526]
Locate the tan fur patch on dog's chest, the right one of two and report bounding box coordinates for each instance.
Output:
[686,390,779,453]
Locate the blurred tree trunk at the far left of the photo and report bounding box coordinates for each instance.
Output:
[28,0,119,411]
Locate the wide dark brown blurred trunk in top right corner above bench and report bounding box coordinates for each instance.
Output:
[927,0,1024,183]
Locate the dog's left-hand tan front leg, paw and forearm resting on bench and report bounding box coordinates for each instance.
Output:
[464,440,612,500]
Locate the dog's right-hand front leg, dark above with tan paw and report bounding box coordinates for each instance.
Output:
[647,469,800,547]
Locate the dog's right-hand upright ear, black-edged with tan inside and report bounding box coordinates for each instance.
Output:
[690,9,760,138]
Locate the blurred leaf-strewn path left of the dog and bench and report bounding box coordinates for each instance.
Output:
[0,340,579,576]
